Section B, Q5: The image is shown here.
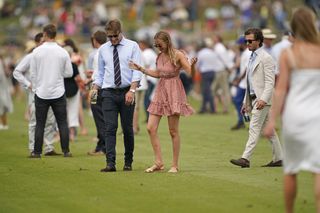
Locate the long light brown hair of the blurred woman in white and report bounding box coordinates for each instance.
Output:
[290,7,320,44]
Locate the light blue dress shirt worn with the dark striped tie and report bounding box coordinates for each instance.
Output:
[94,37,142,88]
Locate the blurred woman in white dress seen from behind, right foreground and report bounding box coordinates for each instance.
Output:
[264,7,320,212]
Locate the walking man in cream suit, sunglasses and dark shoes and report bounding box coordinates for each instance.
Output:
[230,28,282,168]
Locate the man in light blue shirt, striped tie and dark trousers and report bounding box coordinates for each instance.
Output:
[91,20,142,172]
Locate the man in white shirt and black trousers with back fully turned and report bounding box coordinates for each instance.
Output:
[30,24,73,158]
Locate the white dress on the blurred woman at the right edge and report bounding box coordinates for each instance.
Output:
[282,69,320,174]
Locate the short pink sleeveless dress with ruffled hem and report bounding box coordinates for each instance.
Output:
[148,54,194,116]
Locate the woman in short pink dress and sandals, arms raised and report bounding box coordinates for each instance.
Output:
[130,31,197,173]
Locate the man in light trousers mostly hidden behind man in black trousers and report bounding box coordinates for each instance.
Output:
[13,33,59,156]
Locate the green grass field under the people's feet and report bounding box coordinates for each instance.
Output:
[0,96,315,213]
